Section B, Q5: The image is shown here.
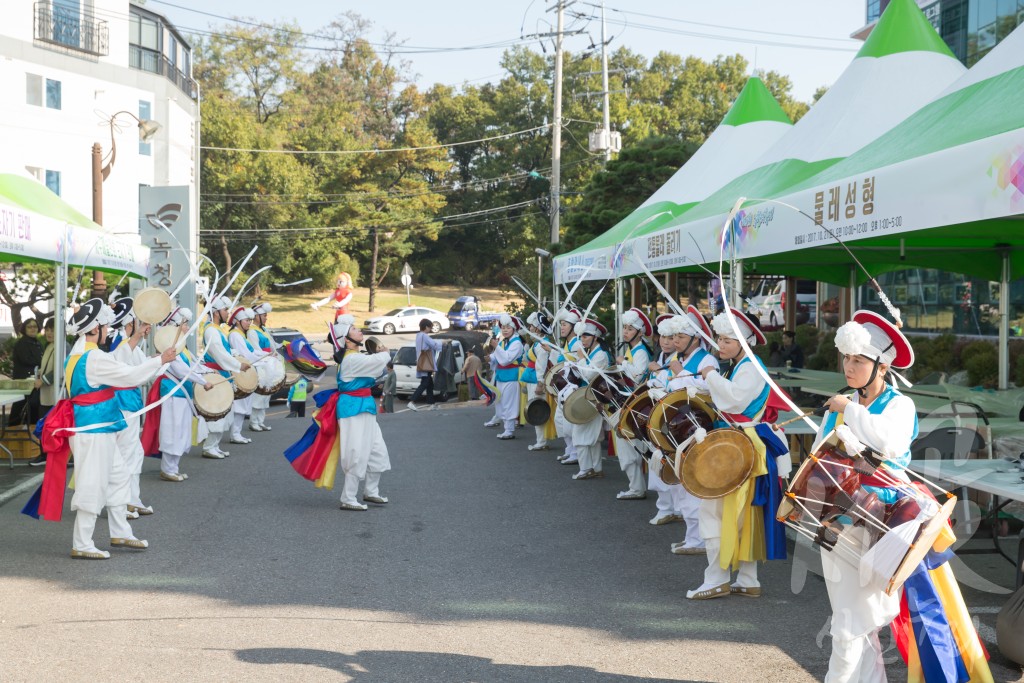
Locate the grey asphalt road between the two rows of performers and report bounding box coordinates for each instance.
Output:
[0,405,1020,683]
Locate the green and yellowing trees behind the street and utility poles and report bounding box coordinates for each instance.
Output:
[195,18,807,296]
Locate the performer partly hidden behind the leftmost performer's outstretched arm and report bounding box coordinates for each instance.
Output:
[111,297,153,519]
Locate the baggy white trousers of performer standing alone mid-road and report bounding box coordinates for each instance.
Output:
[338,413,391,505]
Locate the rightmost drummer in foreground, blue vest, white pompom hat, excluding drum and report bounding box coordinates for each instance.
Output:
[814,310,992,683]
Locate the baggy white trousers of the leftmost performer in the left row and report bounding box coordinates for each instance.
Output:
[70,432,132,552]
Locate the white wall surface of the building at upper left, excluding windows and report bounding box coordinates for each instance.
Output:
[0,0,199,242]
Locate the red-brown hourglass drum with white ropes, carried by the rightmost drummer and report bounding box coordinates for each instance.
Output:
[776,435,956,595]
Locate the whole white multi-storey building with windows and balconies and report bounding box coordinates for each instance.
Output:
[0,0,199,301]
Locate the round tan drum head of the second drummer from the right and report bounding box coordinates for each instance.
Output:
[681,429,755,499]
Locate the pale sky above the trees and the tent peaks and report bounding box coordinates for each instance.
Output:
[145,0,865,102]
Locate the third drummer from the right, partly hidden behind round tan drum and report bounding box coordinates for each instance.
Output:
[669,305,719,555]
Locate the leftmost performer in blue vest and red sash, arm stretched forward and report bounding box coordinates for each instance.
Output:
[51,299,174,559]
